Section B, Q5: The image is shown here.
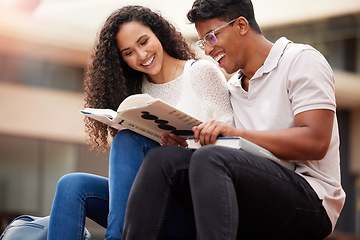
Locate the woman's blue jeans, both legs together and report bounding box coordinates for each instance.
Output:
[48,130,159,240]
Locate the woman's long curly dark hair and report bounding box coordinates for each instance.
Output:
[84,6,195,151]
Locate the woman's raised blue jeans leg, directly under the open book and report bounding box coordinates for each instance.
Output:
[106,130,160,239]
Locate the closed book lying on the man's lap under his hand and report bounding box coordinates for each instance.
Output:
[187,137,295,170]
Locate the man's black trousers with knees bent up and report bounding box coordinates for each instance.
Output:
[123,146,331,240]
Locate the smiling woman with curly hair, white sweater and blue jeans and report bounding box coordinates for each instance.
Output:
[48,6,233,240]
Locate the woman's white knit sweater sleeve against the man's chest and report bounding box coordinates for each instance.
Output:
[189,60,234,126]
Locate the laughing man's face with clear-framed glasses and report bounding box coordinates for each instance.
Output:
[195,18,239,74]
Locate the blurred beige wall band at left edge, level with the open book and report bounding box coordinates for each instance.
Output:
[0,82,85,143]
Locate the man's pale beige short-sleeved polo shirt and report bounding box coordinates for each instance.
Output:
[228,37,345,229]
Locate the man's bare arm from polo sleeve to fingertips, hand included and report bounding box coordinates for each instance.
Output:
[193,109,335,160]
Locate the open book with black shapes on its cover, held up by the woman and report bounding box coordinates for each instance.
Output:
[80,94,202,142]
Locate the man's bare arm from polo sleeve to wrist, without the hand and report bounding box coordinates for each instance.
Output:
[235,110,335,160]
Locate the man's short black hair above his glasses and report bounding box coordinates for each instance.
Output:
[187,0,262,34]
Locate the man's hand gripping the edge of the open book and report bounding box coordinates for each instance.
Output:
[192,120,238,146]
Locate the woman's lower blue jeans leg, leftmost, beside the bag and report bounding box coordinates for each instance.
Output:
[48,173,109,240]
